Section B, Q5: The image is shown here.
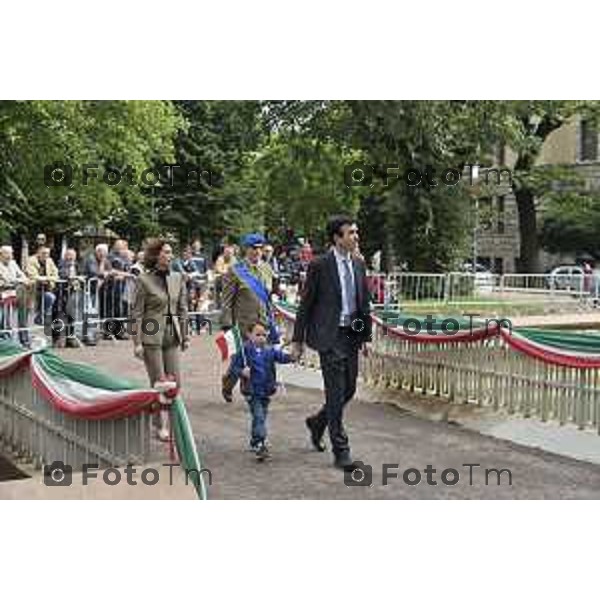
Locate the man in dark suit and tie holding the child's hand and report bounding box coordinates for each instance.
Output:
[292,216,371,471]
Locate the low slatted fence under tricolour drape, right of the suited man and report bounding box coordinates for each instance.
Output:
[282,313,600,434]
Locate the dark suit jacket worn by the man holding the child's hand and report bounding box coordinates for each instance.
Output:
[292,252,371,352]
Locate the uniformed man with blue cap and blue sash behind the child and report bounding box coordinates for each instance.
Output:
[221,233,279,402]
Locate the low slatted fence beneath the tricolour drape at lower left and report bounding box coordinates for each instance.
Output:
[0,358,151,470]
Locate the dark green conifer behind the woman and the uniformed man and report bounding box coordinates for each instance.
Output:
[149,100,266,242]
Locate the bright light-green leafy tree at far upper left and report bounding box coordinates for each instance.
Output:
[0,101,184,234]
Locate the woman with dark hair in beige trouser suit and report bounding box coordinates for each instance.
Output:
[131,240,189,440]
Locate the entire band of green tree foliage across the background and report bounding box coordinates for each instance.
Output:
[0,100,600,270]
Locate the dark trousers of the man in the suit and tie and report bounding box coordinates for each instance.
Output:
[311,327,358,456]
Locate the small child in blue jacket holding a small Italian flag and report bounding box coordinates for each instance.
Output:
[232,323,293,461]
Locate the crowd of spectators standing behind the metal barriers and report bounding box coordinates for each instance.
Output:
[0,234,324,347]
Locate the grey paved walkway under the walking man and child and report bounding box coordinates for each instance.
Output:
[0,337,600,499]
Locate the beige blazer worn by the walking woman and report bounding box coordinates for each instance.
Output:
[131,272,189,346]
